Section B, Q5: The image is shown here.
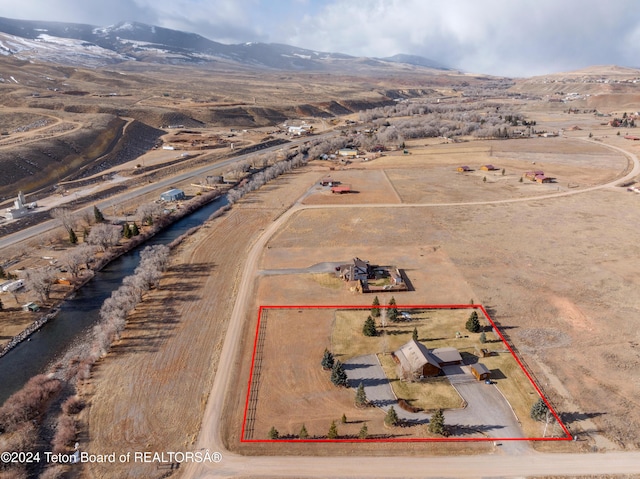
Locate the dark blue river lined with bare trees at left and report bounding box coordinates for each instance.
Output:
[0,196,227,404]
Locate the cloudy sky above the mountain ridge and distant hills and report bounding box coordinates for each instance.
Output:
[0,0,640,76]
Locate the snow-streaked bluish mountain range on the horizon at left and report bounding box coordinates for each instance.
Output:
[0,17,447,70]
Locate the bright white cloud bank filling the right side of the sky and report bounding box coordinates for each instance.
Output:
[280,0,640,75]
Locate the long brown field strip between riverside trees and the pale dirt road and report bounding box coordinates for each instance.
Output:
[83,166,317,478]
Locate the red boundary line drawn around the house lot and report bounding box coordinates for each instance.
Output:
[240,304,574,443]
